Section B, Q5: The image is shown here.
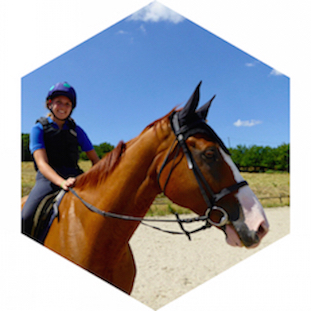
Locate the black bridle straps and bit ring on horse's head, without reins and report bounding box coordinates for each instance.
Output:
[157,112,248,227]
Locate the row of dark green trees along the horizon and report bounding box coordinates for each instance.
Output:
[22,134,290,172]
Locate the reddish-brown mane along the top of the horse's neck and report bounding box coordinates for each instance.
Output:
[75,109,174,193]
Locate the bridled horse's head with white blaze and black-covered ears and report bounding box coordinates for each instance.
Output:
[158,83,269,247]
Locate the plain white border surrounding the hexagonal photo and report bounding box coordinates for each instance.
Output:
[0,0,311,311]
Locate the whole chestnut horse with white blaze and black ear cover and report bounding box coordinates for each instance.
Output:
[22,83,269,294]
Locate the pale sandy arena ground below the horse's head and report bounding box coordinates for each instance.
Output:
[130,207,290,310]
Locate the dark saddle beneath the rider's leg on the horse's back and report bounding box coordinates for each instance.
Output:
[31,190,66,244]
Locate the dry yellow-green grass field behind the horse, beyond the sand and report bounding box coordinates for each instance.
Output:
[21,161,290,216]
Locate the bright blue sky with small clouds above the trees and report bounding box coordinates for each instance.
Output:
[21,2,290,147]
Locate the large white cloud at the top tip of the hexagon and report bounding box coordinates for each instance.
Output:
[129,1,184,24]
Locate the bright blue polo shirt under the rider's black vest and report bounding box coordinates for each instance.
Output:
[29,117,94,154]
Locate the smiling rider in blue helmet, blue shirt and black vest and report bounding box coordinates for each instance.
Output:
[22,82,99,240]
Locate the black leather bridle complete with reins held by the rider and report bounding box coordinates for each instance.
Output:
[69,112,248,240]
